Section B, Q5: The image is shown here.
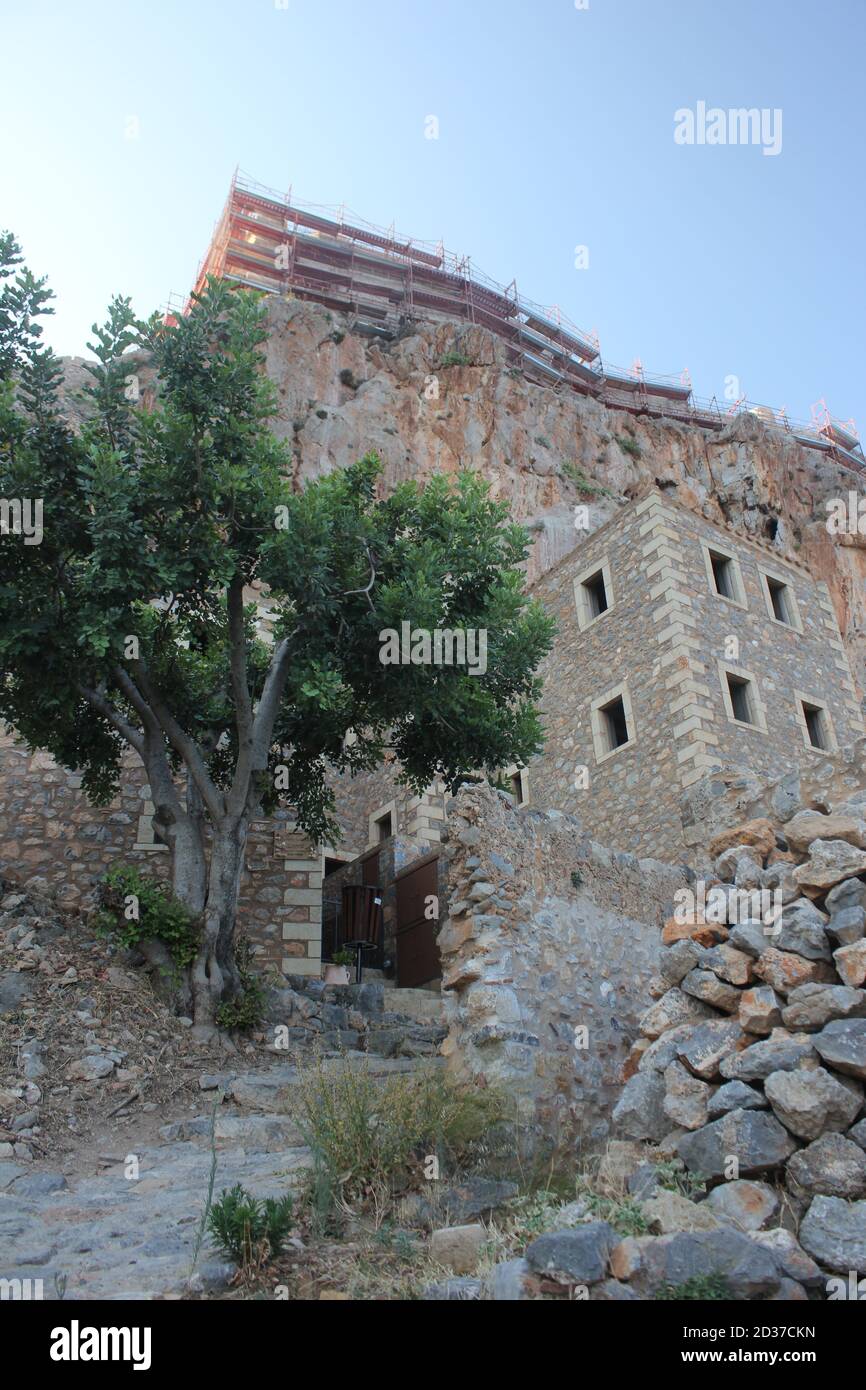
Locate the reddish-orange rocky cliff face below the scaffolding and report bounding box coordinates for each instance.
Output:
[57,297,866,689]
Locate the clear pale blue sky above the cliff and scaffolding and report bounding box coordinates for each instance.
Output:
[0,0,866,432]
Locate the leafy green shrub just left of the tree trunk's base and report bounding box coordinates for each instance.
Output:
[96,865,199,970]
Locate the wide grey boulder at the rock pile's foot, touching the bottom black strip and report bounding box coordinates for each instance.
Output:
[631,1226,780,1300]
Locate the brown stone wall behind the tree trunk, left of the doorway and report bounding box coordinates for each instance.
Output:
[0,735,321,976]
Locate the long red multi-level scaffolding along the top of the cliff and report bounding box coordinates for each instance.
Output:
[186,171,866,473]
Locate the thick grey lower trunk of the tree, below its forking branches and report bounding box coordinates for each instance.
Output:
[190,815,249,1037]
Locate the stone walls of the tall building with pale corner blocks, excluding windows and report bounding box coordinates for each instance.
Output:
[530,491,863,859]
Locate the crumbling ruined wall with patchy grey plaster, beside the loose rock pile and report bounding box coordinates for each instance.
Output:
[439,787,685,1145]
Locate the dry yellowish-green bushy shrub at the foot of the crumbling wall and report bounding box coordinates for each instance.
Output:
[292,1056,505,1212]
